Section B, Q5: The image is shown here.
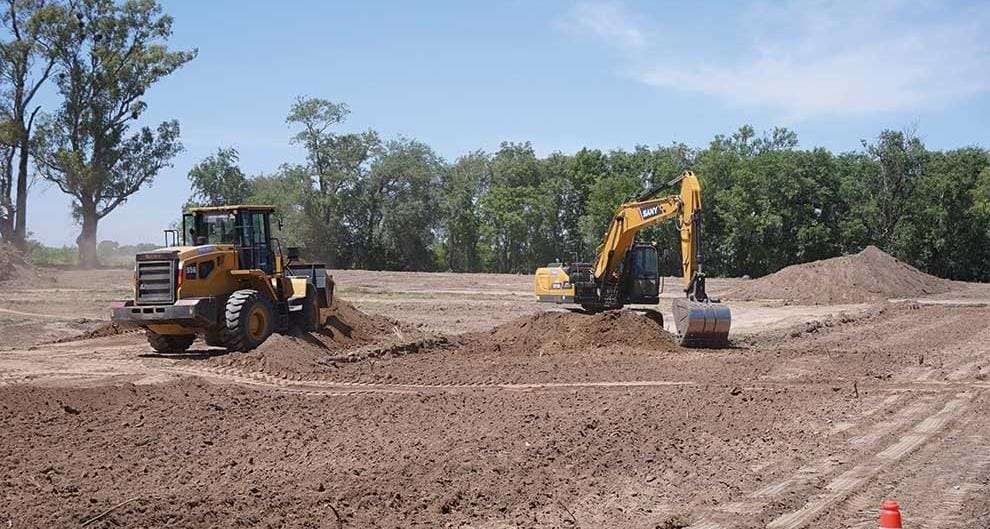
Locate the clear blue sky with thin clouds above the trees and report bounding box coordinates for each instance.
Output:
[28,0,990,244]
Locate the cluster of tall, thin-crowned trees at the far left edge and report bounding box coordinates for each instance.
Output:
[0,0,196,267]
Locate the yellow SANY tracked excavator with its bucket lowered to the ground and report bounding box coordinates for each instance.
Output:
[534,171,732,347]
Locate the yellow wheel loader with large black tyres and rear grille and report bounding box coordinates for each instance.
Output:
[112,205,333,353]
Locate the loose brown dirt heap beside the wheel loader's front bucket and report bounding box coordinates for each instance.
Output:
[205,299,423,377]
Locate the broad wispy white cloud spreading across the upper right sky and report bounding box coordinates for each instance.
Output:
[560,0,990,120]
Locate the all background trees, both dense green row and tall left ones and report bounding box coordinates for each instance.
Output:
[0,0,990,280]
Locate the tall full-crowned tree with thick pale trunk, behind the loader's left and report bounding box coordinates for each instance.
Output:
[39,0,196,267]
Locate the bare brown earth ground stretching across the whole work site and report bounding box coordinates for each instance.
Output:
[0,270,990,529]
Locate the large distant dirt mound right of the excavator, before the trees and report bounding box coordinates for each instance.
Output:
[726,246,952,305]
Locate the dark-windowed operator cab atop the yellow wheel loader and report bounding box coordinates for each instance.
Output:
[182,205,275,275]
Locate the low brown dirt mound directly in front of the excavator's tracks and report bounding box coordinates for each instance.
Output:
[464,310,677,356]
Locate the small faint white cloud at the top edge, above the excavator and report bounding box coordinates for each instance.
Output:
[558,2,647,50]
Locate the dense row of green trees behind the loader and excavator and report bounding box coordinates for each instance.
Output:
[189,97,990,280]
